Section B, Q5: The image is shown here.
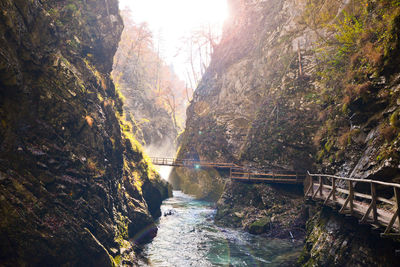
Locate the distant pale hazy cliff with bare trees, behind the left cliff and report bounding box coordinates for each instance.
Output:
[112,9,185,154]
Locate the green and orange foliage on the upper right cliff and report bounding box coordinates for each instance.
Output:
[310,0,400,163]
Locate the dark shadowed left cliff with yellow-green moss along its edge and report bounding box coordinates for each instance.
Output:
[0,0,168,266]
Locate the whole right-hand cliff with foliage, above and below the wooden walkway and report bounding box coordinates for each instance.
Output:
[171,0,400,265]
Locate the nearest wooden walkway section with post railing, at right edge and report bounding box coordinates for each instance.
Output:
[305,173,400,236]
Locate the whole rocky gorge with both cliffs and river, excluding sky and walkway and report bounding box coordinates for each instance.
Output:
[0,0,400,266]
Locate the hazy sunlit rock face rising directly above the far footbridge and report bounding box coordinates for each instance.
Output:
[171,1,319,197]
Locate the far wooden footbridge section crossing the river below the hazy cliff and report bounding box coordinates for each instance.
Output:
[151,157,306,184]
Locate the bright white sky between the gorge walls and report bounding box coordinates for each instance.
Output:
[119,0,228,85]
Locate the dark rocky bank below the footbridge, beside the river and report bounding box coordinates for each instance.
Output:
[215,182,309,240]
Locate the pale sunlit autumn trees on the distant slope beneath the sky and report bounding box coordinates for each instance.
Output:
[112,10,187,133]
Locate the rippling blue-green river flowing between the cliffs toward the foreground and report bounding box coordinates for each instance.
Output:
[142,191,301,267]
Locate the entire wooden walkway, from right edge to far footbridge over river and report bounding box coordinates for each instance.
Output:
[151,158,400,238]
